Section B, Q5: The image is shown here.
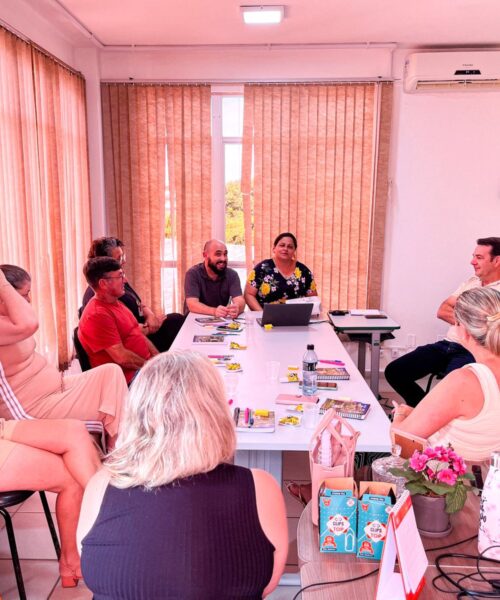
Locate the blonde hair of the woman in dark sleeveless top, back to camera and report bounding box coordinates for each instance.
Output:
[105,351,236,488]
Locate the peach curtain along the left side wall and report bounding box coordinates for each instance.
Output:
[0,28,90,367]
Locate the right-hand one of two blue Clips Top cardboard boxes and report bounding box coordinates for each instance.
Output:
[356,481,396,560]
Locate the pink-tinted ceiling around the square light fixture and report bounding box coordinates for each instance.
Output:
[28,0,500,47]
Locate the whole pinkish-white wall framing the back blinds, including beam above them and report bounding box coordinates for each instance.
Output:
[0,0,500,364]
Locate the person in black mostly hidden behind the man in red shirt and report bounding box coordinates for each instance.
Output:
[80,237,185,352]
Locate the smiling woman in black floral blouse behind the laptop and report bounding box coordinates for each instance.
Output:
[245,232,317,310]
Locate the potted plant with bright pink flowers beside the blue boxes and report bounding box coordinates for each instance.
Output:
[389,445,474,537]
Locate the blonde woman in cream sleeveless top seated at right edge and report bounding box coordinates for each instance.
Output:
[393,287,500,462]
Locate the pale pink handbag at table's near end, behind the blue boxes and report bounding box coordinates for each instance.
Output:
[309,408,360,525]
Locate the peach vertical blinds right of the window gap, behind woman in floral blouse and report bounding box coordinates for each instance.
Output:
[242,83,392,308]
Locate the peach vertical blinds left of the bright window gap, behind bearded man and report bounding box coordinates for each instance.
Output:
[101,83,211,310]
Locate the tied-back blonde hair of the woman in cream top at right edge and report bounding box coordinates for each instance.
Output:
[455,287,500,356]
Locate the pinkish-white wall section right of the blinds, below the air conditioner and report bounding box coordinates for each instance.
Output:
[382,53,500,360]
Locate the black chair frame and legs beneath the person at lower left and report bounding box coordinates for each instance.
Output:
[0,491,61,600]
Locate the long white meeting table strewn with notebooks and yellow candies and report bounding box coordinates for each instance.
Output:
[172,312,390,483]
